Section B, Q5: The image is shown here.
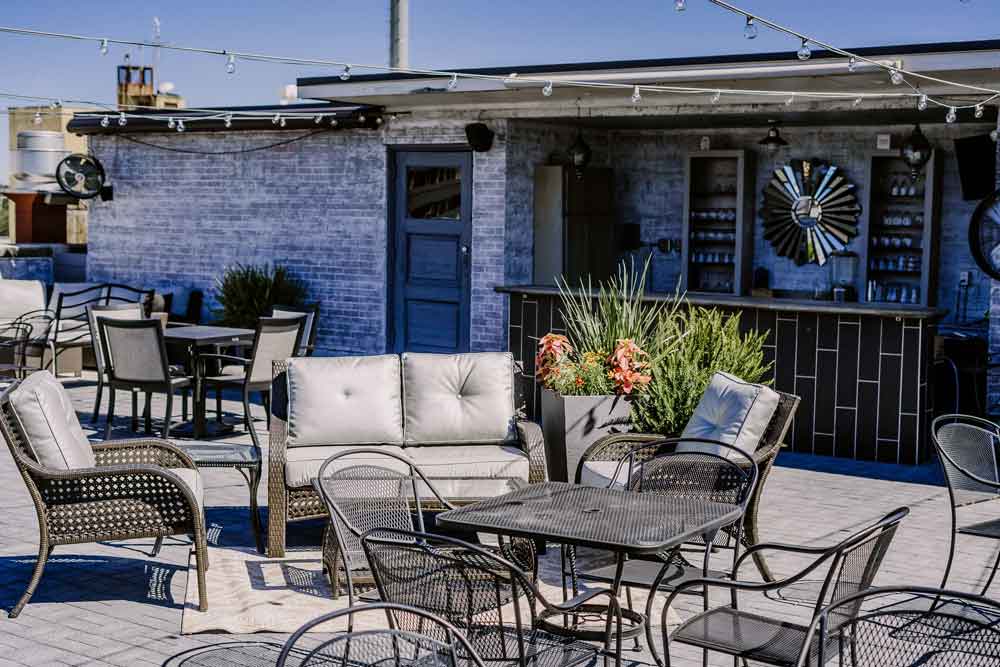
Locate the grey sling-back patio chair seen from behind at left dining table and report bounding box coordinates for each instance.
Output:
[97,317,192,440]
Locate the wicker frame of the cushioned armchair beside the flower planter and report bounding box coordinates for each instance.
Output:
[575,392,800,582]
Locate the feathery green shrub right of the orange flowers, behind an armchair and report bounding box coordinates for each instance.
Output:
[632,306,771,436]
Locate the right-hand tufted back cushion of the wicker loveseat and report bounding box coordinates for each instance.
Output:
[403,352,516,446]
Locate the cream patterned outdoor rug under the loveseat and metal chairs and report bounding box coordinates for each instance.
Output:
[181,546,673,635]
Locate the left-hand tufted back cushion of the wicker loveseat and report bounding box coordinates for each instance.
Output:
[288,354,403,447]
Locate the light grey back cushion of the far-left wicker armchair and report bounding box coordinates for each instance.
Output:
[10,371,95,470]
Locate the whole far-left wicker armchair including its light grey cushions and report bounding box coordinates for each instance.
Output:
[0,371,208,617]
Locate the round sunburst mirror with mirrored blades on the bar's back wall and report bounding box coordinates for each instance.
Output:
[763,160,861,266]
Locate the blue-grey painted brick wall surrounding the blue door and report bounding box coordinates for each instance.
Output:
[88,119,507,354]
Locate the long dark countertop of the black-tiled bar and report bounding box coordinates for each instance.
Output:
[496,285,947,319]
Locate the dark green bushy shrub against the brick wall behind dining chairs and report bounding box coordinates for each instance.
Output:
[215,264,306,329]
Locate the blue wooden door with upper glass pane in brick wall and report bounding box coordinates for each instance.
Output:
[391,151,472,353]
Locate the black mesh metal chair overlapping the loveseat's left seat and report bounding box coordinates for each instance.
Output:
[313,447,536,604]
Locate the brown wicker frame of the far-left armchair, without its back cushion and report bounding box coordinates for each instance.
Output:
[0,371,208,617]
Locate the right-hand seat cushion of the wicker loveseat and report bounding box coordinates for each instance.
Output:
[405,445,530,499]
